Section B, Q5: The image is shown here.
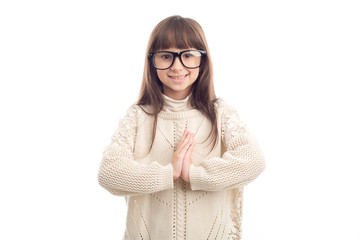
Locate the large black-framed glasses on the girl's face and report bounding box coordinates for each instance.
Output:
[149,49,206,70]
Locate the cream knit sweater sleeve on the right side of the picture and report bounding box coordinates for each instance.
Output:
[189,100,265,191]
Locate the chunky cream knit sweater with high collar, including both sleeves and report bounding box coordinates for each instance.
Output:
[98,95,265,240]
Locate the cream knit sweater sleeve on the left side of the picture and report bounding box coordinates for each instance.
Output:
[98,105,173,196]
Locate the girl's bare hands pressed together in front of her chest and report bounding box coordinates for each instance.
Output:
[171,130,195,182]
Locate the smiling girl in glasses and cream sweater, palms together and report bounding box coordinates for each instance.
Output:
[98,16,265,240]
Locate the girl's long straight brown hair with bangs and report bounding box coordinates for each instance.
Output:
[137,15,219,150]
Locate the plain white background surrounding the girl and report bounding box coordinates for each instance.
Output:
[0,0,360,240]
